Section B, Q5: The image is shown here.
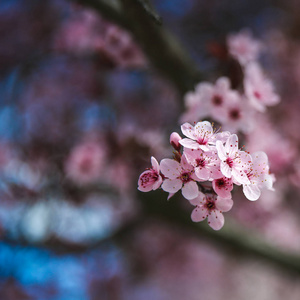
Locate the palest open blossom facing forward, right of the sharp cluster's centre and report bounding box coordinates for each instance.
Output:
[216,134,251,184]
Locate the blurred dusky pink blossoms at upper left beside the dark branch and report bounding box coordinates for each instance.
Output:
[54,10,146,68]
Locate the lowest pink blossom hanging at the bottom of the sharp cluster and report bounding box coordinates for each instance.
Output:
[190,192,233,230]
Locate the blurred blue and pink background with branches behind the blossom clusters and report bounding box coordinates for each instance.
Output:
[0,0,300,300]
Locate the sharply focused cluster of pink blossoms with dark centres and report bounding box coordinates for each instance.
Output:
[138,121,274,230]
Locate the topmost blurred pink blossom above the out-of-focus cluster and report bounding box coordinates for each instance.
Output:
[227,30,263,65]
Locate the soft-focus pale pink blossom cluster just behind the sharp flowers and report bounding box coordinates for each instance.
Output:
[181,30,280,133]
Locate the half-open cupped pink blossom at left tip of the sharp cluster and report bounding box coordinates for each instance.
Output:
[138,156,162,192]
